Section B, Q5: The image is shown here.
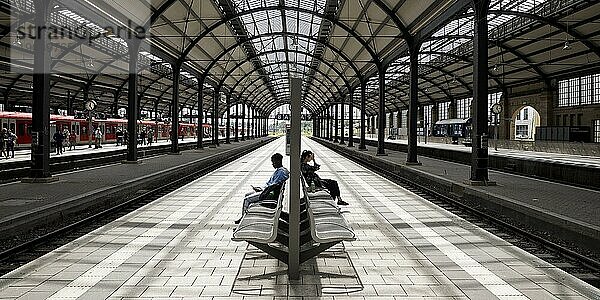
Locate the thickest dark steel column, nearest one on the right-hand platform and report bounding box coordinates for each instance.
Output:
[470,0,490,185]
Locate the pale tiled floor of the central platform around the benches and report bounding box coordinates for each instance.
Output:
[0,139,600,299]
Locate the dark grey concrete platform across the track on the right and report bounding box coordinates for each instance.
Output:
[318,139,600,253]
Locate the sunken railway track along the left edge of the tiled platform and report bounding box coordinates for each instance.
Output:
[0,138,272,276]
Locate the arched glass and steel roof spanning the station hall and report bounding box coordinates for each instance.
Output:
[0,0,600,118]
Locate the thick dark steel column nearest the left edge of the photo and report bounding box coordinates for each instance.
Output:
[29,0,52,181]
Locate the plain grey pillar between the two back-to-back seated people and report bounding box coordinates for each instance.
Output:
[288,78,302,280]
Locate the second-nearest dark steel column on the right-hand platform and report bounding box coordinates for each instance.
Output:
[406,44,421,165]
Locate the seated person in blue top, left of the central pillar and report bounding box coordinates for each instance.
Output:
[235,153,290,224]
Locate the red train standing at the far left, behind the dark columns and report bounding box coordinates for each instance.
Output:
[0,111,212,146]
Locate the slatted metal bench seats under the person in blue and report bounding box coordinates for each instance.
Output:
[231,183,285,244]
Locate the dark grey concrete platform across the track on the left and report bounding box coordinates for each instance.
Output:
[0,138,269,239]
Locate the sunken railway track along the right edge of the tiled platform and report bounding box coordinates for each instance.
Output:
[321,139,600,288]
